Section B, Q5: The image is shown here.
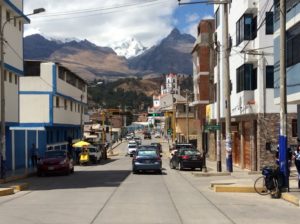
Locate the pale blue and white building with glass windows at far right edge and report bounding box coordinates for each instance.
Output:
[274,0,300,136]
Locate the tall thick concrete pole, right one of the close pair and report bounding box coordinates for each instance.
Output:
[223,1,233,172]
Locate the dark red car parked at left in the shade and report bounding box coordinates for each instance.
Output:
[37,150,74,176]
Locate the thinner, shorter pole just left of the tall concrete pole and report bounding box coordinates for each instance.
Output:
[215,38,222,172]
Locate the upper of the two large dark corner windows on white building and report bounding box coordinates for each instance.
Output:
[236,14,257,45]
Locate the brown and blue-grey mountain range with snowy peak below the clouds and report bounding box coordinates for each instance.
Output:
[24,28,195,80]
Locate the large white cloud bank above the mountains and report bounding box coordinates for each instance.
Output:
[24,0,177,46]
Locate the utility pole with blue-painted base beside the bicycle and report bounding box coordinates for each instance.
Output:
[279,0,289,189]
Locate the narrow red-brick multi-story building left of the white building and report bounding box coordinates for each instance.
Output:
[192,19,215,151]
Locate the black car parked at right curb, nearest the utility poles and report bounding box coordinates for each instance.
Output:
[170,148,203,171]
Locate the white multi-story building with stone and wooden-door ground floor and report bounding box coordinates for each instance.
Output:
[212,0,296,170]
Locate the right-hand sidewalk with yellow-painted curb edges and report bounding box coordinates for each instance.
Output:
[198,160,300,206]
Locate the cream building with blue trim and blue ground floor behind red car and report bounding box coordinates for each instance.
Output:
[8,61,87,170]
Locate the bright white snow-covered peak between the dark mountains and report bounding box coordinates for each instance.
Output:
[110,37,146,58]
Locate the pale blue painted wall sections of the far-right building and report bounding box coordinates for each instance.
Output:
[274,3,300,100]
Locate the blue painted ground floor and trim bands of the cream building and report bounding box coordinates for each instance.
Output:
[6,64,83,170]
